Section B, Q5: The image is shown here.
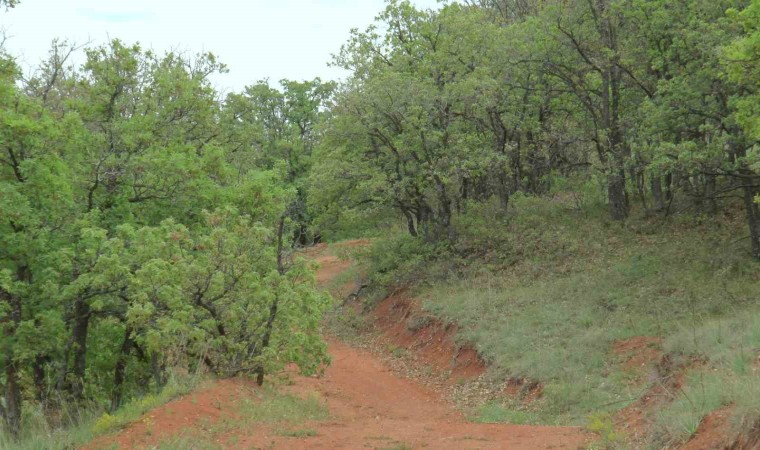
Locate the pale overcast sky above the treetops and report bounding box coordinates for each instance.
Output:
[0,0,438,90]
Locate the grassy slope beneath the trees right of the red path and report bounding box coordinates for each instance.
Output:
[348,189,760,448]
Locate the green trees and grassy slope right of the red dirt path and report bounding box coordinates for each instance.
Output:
[309,0,760,448]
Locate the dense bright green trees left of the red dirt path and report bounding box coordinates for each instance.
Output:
[0,40,332,435]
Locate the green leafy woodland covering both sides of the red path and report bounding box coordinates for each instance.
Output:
[0,0,760,443]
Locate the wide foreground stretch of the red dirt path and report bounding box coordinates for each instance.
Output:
[239,341,588,450]
